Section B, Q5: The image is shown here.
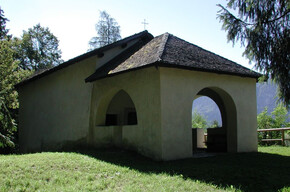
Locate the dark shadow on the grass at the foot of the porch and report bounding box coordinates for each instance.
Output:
[80,149,290,191]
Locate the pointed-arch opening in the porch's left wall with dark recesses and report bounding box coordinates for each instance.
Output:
[105,90,138,126]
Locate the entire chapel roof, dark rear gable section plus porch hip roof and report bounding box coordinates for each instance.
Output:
[16,31,261,87]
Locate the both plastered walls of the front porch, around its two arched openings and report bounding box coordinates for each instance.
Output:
[89,67,257,160]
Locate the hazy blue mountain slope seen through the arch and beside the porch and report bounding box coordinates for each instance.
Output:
[192,81,289,125]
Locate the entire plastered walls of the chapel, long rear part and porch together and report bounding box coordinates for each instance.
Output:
[19,62,257,160]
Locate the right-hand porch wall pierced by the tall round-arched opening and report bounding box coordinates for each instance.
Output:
[160,68,257,160]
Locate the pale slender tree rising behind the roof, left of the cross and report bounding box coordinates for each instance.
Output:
[89,11,121,50]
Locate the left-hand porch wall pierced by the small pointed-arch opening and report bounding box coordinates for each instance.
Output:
[89,67,161,160]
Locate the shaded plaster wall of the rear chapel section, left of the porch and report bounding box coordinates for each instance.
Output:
[19,42,138,152]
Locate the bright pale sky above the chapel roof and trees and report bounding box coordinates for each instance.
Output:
[0,0,253,68]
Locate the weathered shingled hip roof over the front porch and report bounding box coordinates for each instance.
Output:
[107,33,261,78]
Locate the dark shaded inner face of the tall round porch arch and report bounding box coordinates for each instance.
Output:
[194,87,237,152]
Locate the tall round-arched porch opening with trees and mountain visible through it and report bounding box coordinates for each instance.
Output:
[192,88,237,152]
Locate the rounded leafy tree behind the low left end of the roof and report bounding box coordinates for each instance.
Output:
[16,24,63,71]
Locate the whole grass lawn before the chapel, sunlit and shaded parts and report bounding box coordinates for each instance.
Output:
[0,147,290,191]
